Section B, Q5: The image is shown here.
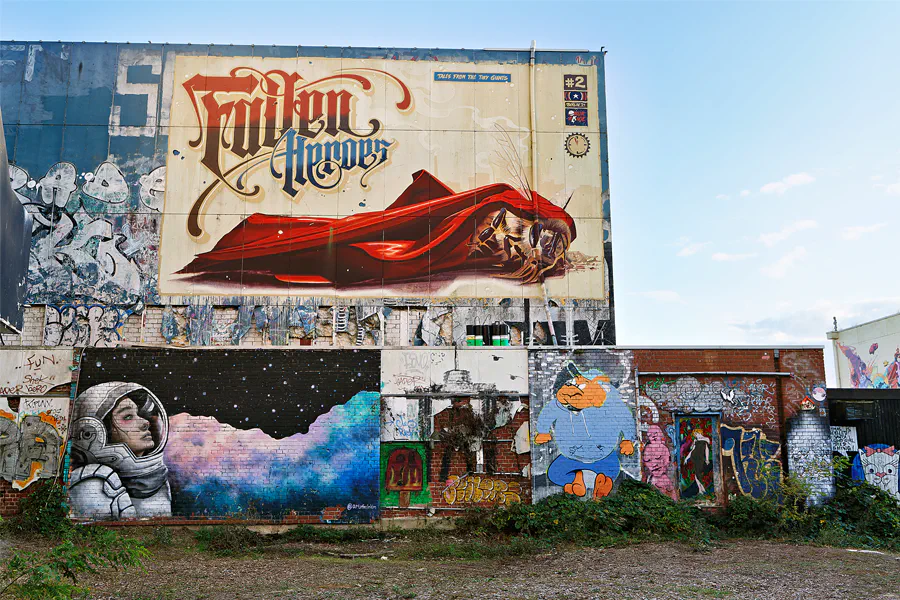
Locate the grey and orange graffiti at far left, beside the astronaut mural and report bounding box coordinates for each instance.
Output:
[0,398,69,490]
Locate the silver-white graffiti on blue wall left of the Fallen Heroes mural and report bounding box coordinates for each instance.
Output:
[13,162,159,307]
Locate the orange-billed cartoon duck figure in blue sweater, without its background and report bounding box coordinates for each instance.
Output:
[534,363,636,499]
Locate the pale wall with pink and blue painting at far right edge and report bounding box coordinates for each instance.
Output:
[829,315,900,389]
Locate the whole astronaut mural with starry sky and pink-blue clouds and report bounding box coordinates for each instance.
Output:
[69,349,381,521]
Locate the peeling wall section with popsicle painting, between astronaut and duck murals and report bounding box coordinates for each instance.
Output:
[381,348,531,508]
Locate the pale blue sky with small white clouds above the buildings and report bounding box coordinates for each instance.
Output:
[0,0,900,382]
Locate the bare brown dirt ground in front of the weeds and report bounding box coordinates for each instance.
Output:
[68,539,900,600]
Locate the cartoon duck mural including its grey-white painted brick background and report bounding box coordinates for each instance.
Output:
[530,351,640,500]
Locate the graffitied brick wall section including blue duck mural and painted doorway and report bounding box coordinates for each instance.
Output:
[529,349,833,505]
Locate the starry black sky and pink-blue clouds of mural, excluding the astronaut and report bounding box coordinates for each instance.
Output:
[78,348,381,521]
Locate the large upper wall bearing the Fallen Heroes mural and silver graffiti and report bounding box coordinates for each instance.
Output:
[0,42,615,346]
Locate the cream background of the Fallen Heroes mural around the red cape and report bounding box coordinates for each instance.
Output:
[159,56,606,299]
